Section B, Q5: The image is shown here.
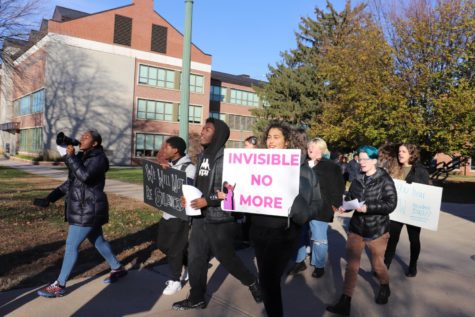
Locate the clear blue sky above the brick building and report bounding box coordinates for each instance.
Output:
[39,0,355,80]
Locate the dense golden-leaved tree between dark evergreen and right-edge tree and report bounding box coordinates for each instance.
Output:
[312,2,412,150]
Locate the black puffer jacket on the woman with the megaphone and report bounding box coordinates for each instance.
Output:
[47,149,109,227]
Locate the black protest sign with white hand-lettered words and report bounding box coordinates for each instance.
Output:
[142,160,188,220]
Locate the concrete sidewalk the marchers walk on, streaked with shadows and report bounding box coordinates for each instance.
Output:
[0,160,475,317]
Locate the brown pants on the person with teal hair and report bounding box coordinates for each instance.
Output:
[343,232,389,297]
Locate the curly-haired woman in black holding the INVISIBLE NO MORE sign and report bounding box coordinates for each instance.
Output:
[250,121,321,317]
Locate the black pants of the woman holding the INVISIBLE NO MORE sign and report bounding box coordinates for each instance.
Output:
[250,223,300,317]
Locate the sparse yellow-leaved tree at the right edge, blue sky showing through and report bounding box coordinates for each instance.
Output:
[388,0,475,154]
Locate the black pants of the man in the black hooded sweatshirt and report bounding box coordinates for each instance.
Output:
[188,218,256,303]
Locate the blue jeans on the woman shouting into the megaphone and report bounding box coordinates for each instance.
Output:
[58,225,121,285]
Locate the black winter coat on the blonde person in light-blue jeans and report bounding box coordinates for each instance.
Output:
[312,159,345,222]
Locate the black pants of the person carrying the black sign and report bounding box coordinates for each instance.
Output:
[157,218,190,281]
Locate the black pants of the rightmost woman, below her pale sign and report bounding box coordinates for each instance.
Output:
[384,221,421,267]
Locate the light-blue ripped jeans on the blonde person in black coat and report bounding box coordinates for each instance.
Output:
[295,220,328,268]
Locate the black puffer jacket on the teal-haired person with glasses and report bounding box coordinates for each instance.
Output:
[345,167,397,239]
